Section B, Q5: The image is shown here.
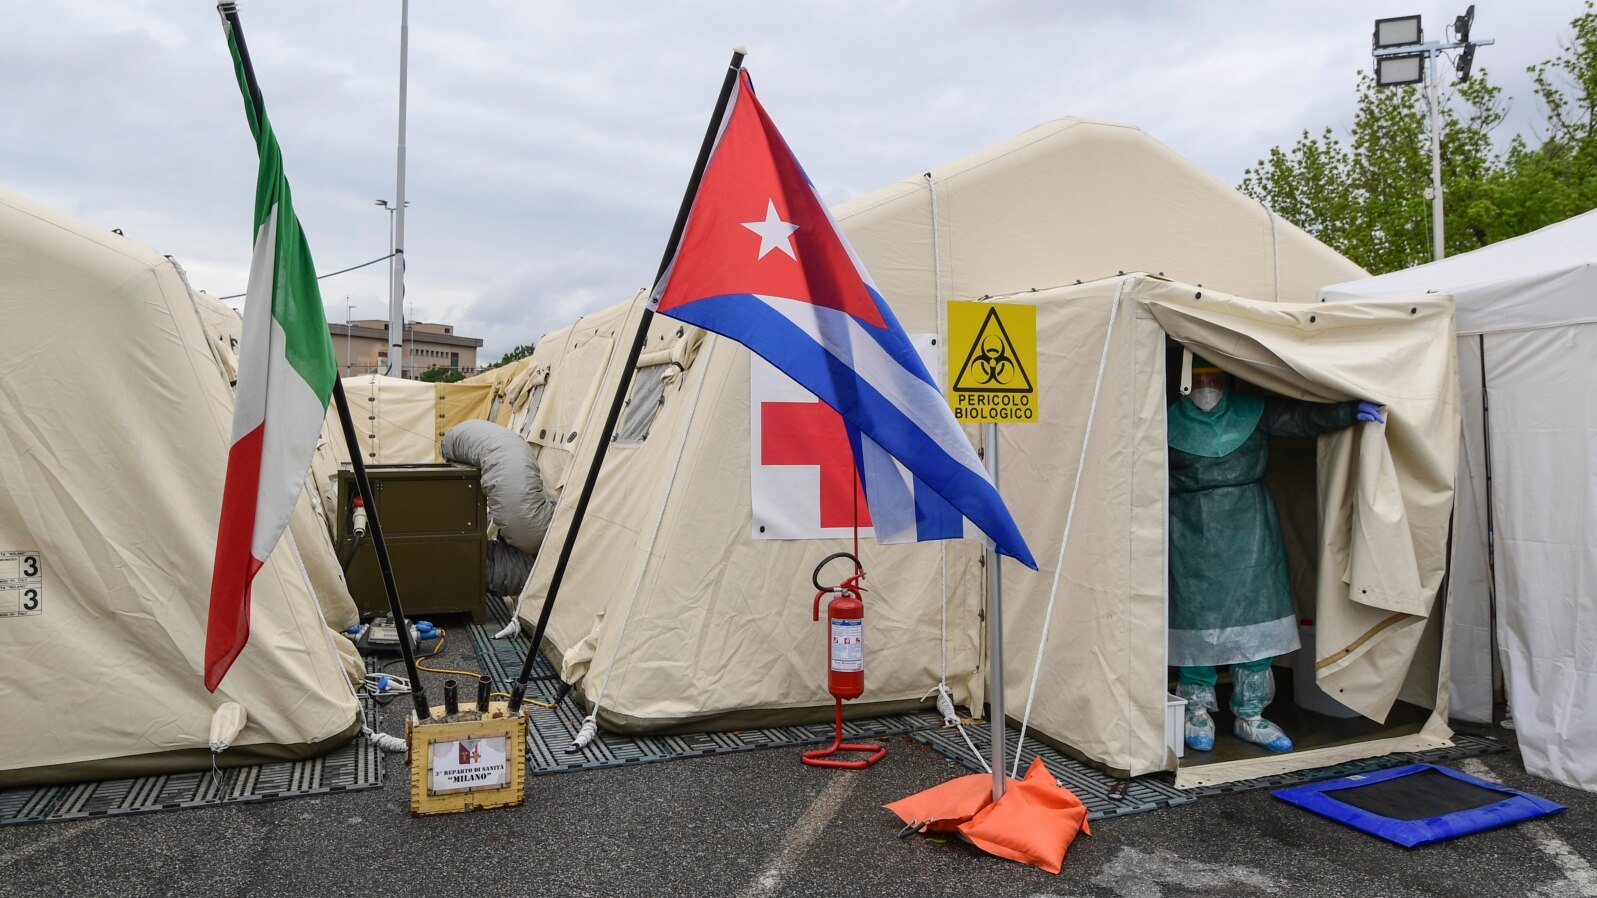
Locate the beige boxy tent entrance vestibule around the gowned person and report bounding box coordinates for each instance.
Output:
[993,276,1458,785]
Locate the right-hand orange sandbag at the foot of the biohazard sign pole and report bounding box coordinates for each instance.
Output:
[951,757,1092,872]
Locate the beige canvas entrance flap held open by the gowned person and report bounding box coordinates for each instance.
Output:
[1143,281,1458,721]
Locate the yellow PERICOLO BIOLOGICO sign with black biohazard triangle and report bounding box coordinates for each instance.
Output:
[949,302,1038,423]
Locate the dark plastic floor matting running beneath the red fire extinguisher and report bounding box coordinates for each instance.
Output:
[470,596,942,773]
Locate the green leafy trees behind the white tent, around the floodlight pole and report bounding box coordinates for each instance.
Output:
[1239,0,1597,273]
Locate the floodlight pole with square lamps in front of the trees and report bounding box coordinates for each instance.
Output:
[1370,3,1496,259]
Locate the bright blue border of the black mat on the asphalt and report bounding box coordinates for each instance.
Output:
[1270,764,1565,848]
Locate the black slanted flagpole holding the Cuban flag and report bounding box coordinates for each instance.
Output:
[509,46,747,714]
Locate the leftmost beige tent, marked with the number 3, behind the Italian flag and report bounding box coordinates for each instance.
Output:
[0,190,361,786]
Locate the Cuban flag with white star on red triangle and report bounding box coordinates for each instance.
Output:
[650,70,1036,569]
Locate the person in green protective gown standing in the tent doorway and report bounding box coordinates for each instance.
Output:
[1166,360,1385,751]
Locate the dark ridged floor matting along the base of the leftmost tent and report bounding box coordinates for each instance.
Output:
[0,737,383,826]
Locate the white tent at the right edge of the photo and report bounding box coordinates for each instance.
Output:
[1321,213,1597,789]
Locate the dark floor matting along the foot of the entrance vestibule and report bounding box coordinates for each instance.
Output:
[915,724,1508,820]
